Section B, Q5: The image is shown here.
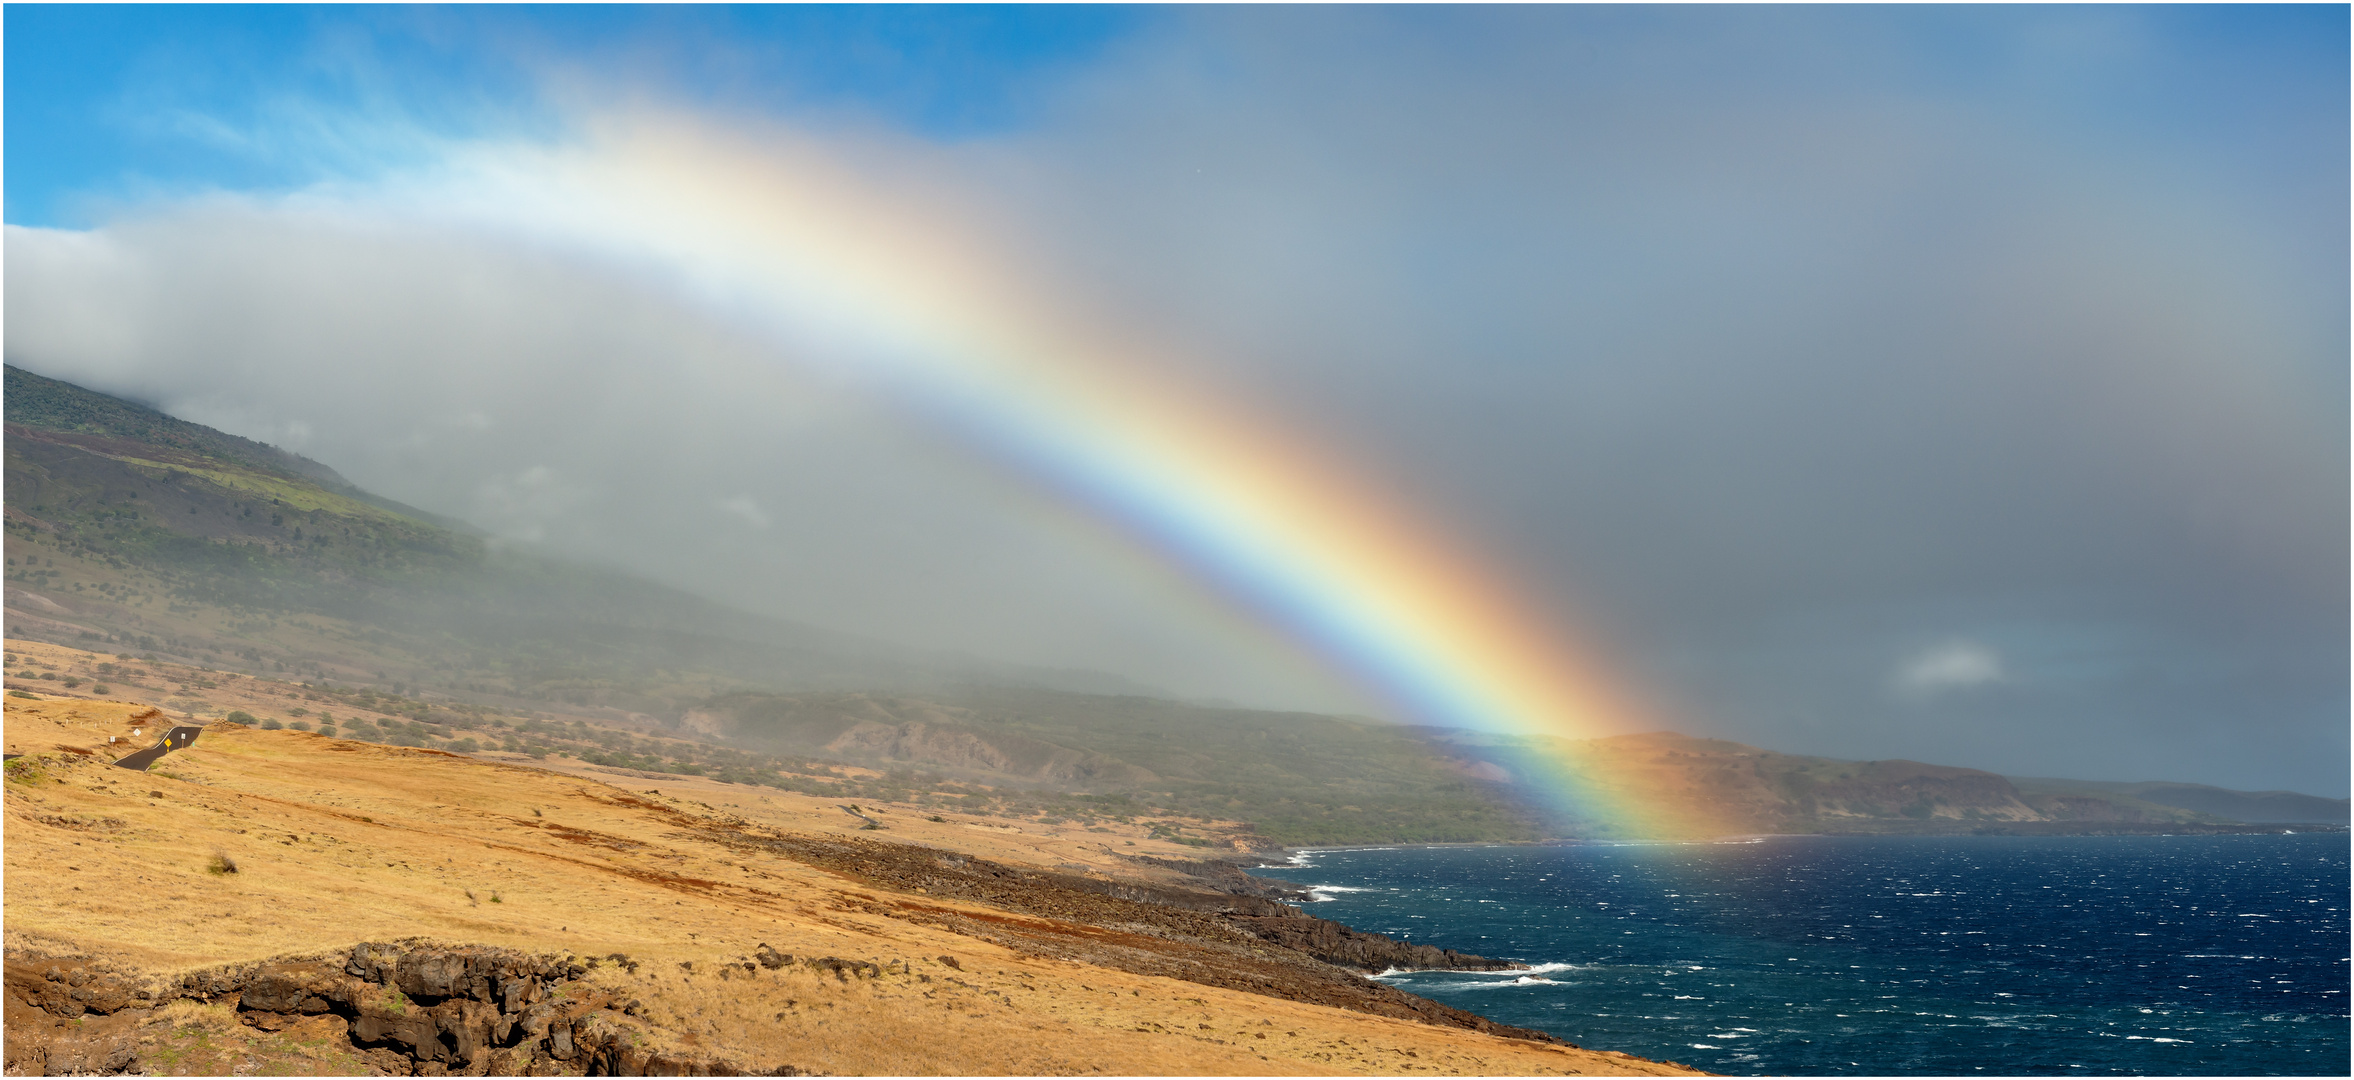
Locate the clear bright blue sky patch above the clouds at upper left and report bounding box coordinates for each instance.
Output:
[5,5,1151,226]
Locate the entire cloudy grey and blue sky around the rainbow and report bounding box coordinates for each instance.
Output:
[5,5,2349,795]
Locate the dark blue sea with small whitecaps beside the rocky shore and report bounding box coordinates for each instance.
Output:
[1257,833,2354,1075]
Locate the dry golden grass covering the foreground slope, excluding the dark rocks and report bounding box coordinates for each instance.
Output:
[5,658,1676,1075]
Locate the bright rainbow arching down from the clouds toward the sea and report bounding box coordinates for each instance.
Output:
[424,113,1685,837]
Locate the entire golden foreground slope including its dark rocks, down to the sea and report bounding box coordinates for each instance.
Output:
[5,692,1681,1075]
